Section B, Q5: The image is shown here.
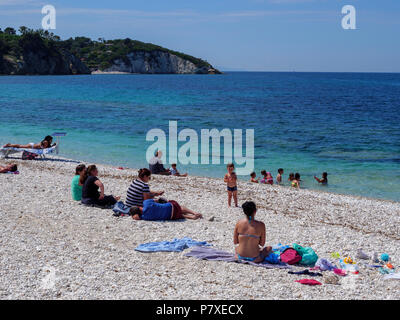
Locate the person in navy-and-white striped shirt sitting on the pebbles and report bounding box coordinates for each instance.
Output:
[125,168,164,207]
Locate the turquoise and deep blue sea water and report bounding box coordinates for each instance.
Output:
[0,72,400,201]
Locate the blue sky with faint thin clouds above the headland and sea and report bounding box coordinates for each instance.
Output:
[0,0,400,72]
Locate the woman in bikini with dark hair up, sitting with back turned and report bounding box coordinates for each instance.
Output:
[233,201,272,263]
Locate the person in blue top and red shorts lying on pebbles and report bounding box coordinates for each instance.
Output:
[130,199,203,221]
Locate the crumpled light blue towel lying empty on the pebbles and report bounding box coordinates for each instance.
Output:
[135,237,211,252]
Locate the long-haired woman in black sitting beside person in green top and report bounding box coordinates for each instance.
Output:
[79,165,120,207]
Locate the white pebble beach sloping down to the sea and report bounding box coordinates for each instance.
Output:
[0,157,400,300]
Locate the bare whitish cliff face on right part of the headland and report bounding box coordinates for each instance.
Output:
[103,51,208,74]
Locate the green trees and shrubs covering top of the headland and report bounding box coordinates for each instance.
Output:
[0,27,218,74]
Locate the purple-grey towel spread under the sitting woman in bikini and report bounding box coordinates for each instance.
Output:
[184,247,291,269]
